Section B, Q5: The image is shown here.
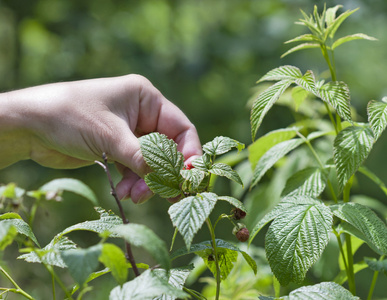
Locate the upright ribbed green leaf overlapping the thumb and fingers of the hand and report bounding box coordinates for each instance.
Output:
[139,132,184,178]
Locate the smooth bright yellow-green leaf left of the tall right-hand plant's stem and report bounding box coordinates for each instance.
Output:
[248,127,301,169]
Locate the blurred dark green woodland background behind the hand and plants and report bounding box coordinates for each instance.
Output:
[0,0,387,299]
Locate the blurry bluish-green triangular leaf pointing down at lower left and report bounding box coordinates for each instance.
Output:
[60,244,102,286]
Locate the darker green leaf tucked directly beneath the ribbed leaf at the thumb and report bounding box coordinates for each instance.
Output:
[144,173,181,198]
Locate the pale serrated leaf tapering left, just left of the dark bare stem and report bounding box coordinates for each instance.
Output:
[57,207,122,237]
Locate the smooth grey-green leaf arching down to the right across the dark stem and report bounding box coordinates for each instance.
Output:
[111,224,170,270]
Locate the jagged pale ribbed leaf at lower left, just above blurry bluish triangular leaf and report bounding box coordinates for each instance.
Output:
[18,236,76,268]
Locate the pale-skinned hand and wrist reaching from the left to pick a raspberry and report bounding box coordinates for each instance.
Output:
[0,75,202,203]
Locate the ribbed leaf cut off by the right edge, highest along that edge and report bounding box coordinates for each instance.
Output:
[367,97,387,141]
